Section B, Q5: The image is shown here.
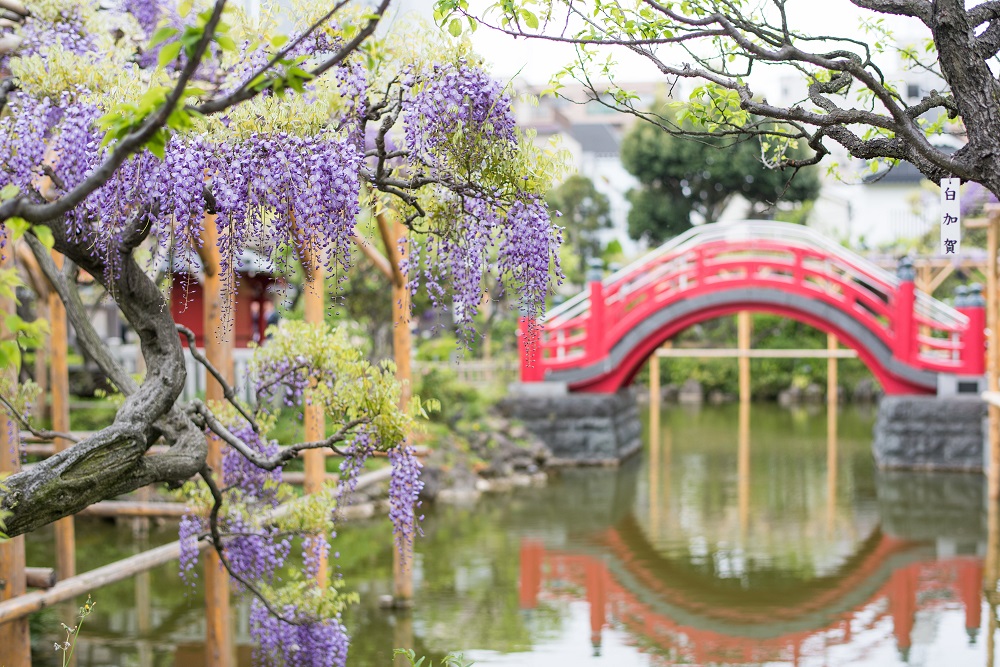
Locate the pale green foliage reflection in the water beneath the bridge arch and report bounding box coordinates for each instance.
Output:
[635,405,879,580]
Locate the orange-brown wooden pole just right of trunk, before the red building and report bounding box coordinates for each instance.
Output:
[200,215,234,667]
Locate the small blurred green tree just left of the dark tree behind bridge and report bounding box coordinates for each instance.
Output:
[545,174,611,283]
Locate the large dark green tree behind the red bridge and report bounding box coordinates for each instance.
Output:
[621,123,820,244]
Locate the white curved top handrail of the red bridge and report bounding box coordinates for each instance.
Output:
[542,220,969,328]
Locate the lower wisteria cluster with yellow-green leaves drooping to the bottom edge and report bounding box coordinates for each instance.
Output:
[172,321,414,665]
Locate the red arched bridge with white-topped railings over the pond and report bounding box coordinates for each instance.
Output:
[521,221,985,394]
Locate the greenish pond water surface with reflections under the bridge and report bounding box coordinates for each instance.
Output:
[19,405,989,667]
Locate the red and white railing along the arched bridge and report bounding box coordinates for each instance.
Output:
[523,221,983,380]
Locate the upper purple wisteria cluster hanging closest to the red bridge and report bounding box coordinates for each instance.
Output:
[394,58,562,338]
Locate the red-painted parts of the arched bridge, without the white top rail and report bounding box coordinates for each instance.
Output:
[522,231,985,394]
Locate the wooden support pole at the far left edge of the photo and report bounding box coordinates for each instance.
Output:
[0,237,31,667]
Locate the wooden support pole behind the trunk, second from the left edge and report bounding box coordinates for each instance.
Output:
[49,251,76,579]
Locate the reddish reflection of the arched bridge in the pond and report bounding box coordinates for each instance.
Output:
[520,529,983,665]
